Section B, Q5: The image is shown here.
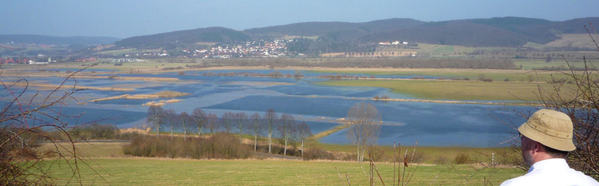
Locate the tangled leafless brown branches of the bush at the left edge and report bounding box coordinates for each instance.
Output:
[0,64,106,185]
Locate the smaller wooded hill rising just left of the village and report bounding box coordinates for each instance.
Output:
[115,27,251,49]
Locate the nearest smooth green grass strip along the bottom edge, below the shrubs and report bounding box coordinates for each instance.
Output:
[41,158,524,185]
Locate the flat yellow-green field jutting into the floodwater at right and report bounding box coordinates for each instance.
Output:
[318,80,568,101]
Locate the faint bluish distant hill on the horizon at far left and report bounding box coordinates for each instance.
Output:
[0,35,119,45]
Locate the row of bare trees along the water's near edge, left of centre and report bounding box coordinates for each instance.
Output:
[147,106,312,155]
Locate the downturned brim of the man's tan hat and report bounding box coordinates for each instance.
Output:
[518,123,576,152]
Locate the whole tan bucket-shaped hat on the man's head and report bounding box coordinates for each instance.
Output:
[518,109,576,151]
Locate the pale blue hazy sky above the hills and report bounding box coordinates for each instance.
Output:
[0,0,599,38]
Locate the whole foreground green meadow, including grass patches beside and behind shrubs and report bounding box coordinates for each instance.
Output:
[36,142,524,185]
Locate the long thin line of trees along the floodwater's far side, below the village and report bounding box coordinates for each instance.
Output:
[210,58,516,69]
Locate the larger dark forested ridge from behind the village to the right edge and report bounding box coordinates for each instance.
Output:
[245,17,599,47]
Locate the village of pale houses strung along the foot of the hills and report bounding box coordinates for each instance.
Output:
[0,39,418,65]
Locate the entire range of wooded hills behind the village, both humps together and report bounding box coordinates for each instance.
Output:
[116,17,599,48]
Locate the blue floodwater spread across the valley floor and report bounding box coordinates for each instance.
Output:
[3,70,534,147]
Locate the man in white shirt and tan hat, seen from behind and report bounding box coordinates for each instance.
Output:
[501,109,599,186]
